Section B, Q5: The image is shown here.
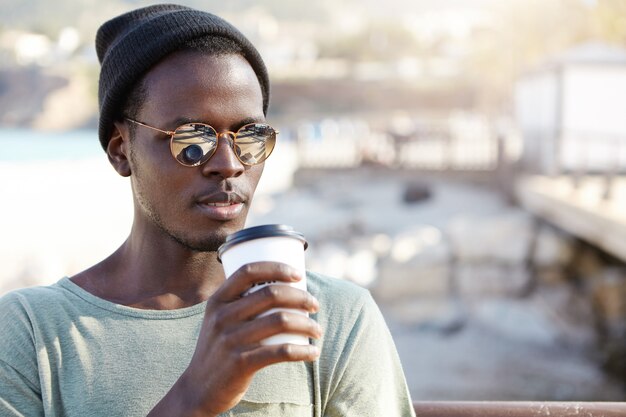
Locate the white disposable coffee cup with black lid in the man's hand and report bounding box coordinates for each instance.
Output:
[218,224,309,345]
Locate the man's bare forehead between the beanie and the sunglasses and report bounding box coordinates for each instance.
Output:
[141,51,263,127]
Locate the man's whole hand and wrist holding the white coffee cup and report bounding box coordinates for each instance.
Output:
[149,262,321,416]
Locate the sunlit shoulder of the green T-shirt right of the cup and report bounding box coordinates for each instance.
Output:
[307,273,415,416]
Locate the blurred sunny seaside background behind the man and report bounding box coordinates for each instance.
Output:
[0,0,626,401]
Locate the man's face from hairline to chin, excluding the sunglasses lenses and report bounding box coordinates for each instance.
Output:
[120,52,264,251]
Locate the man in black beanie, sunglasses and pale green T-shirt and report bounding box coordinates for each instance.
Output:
[0,5,413,417]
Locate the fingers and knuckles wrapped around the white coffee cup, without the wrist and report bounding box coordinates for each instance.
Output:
[200,262,322,372]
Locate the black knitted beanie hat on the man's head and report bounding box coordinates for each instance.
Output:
[96,4,269,150]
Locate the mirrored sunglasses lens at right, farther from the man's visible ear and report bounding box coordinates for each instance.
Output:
[235,123,276,165]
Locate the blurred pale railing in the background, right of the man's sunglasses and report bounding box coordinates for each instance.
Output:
[297,117,501,172]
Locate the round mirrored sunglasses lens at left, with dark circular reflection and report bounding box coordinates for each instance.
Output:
[171,123,217,166]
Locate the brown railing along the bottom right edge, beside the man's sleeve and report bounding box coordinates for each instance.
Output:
[414,401,626,417]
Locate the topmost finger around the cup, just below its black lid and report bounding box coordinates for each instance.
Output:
[213,262,303,302]
